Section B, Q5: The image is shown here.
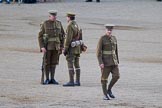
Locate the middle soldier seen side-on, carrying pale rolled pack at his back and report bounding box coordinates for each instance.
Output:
[63,13,82,86]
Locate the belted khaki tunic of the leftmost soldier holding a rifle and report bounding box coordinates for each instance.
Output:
[38,20,65,50]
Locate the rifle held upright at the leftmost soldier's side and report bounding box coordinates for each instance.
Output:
[41,34,48,84]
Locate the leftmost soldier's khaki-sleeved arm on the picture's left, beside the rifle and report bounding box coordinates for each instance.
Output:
[38,24,45,51]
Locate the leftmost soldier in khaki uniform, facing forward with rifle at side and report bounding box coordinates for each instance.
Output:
[38,10,65,84]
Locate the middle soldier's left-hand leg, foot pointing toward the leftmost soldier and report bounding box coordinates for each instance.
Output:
[63,55,74,86]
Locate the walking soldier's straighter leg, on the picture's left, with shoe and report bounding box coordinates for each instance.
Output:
[101,66,110,100]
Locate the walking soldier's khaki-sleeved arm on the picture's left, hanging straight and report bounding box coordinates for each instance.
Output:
[96,37,103,65]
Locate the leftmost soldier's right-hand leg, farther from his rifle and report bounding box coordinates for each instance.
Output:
[50,50,59,84]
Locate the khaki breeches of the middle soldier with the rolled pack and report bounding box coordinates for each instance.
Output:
[66,54,80,70]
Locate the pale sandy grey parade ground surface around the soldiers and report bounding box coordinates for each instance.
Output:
[0,0,162,108]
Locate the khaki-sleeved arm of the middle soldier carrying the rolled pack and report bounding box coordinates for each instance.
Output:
[64,26,74,51]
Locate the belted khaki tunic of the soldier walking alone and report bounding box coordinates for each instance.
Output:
[97,35,119,66]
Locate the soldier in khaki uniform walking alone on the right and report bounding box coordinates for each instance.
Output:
[97,24,120,100]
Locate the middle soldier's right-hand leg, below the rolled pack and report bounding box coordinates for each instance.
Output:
[74,55,80,86]
